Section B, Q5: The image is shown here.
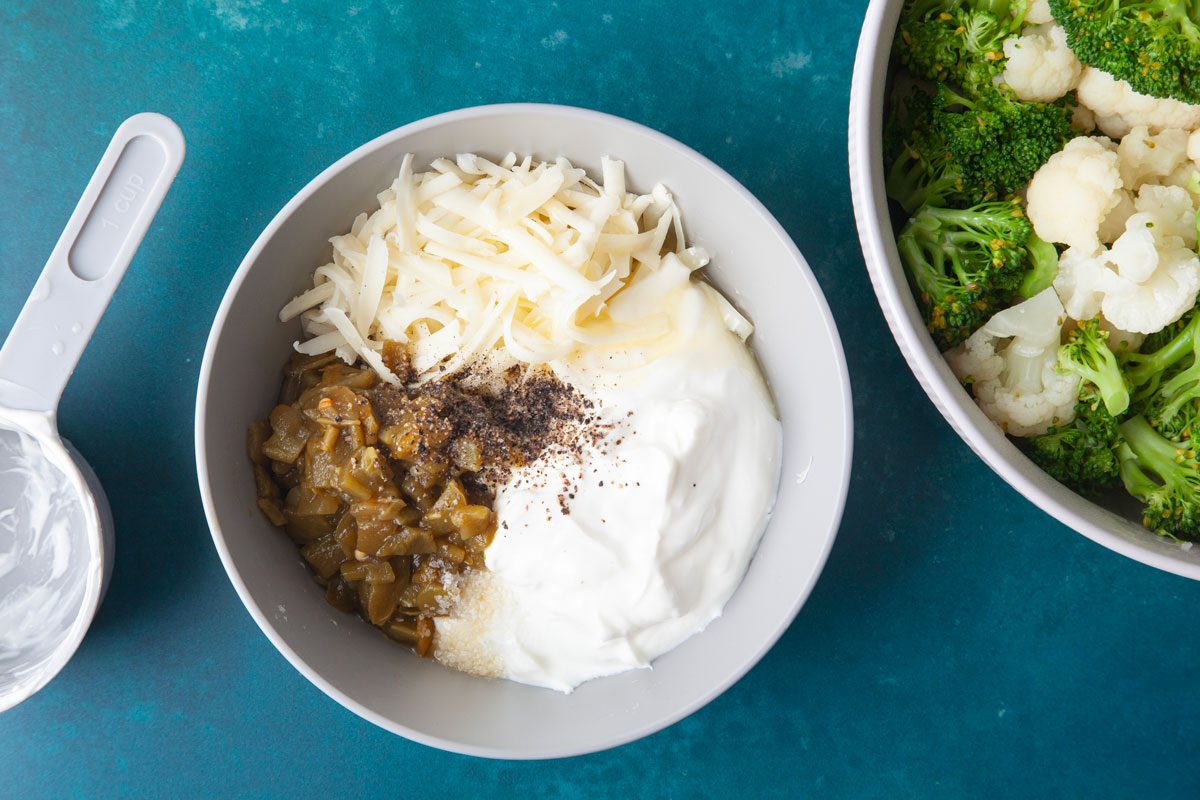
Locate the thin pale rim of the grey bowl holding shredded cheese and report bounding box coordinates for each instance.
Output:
[194,103,853,760]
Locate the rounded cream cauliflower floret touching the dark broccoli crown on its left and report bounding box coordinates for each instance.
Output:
[1027,137,1122,251]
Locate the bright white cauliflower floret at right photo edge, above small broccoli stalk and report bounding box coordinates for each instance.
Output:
[1054,211,1200,333]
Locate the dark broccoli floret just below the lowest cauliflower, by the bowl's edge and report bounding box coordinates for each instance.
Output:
[1028,383,1121,497]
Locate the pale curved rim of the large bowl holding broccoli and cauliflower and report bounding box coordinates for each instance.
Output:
[848,0,1200,581]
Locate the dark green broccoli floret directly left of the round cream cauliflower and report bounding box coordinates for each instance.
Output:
[884,85,1075,214]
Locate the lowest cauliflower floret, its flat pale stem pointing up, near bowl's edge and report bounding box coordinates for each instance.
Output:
[946,289,1079,437]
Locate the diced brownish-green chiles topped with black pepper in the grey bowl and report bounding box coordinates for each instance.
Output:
[247,357,588,655]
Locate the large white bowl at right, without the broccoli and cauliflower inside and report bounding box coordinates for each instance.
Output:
[850,0,1200,579]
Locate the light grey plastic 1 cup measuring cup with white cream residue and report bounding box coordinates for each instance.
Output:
[0,114,184,711]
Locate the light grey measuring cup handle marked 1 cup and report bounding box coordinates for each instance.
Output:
[0,114,184,411]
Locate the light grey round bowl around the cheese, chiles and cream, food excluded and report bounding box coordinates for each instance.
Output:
[196,106,851,758]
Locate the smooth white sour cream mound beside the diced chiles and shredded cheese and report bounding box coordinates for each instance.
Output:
[436,259,782,692]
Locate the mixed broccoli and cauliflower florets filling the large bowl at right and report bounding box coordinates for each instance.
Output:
[884,0,1200,540]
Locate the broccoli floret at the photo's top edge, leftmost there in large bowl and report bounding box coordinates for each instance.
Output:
[895,0,1026,95]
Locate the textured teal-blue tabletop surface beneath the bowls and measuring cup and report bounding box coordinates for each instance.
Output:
[0,0,1200,798]
